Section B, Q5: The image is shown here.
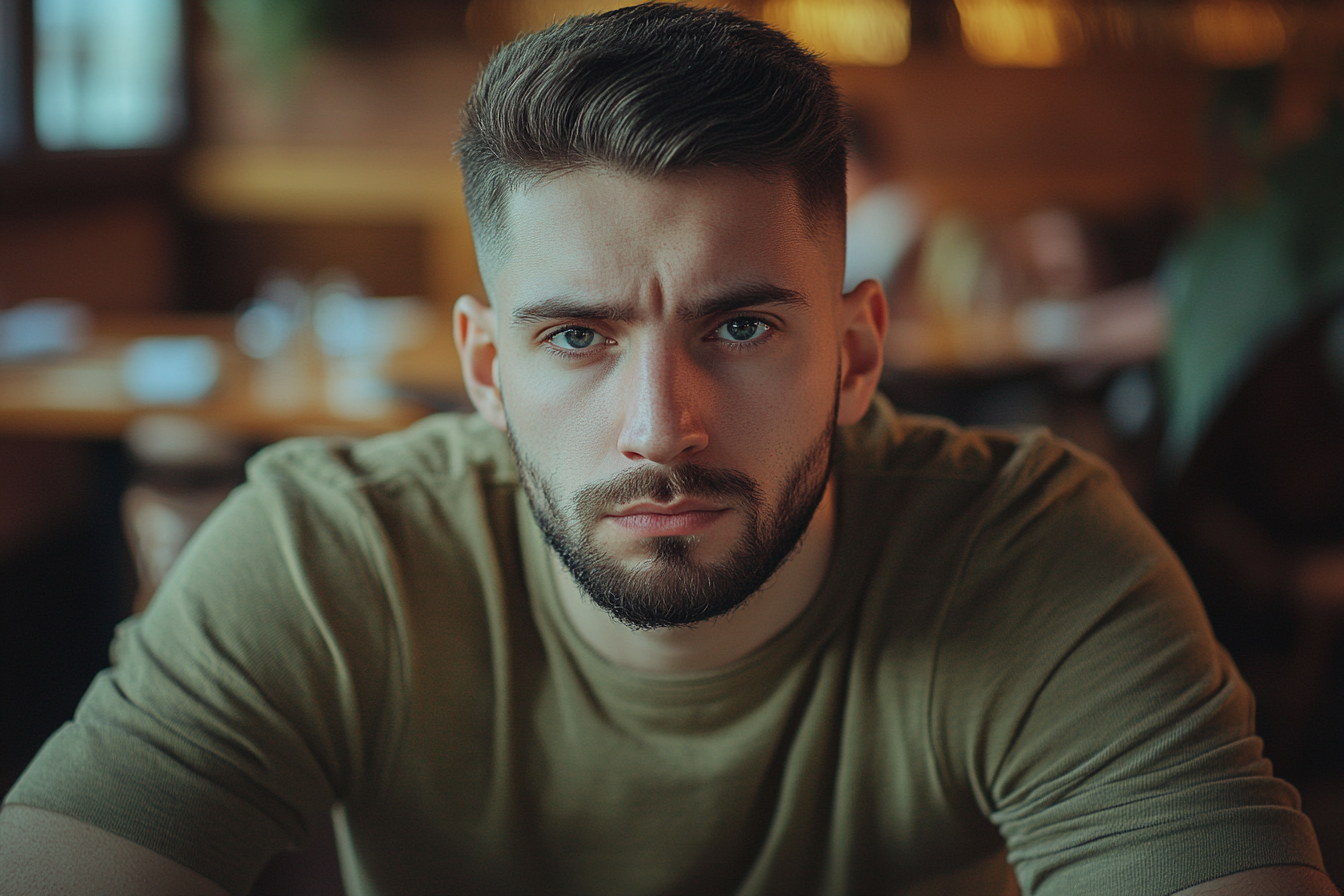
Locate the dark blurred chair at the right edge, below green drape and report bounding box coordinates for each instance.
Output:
[1161,294,1344,772]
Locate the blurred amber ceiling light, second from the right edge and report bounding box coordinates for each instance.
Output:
[957,0,1081,69]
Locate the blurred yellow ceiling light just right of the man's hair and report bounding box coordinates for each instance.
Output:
[762,0,910,66]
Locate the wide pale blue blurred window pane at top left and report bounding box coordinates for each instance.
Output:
[34,0,183,149]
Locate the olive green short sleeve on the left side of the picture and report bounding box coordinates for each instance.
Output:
[5,451,399,893]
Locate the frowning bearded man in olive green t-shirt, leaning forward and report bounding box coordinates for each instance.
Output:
[4,5,1333,895]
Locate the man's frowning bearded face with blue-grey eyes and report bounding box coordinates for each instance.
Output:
[478,171,843,627]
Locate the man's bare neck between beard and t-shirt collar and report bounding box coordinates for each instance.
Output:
[551,481,836,673]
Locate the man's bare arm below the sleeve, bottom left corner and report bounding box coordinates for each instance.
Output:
[0,806,227,896]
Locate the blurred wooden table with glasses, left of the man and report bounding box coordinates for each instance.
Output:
[0,314,461,442]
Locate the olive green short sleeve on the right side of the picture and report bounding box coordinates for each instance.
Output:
[931,429,1321,896]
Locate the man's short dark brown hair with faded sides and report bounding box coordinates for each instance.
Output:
[457,3,845,257]
